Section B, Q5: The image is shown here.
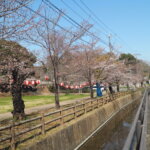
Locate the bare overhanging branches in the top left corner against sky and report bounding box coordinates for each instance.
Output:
[0,0,40,39]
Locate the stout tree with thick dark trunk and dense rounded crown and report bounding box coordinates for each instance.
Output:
[0,40,36,119]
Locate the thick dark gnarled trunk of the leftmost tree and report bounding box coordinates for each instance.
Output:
[11,83,25,120]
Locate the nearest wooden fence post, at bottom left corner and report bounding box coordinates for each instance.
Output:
[10,121,16,150]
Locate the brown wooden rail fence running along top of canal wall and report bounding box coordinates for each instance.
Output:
[0,92,129,150]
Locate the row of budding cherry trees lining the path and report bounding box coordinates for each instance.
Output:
[0,0,149,119]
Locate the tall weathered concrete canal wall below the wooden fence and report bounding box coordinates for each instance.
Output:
[20,91,141,150]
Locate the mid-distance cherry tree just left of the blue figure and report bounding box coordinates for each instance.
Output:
[71,40,103,98]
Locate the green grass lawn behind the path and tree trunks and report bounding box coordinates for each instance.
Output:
[0,94,89,113]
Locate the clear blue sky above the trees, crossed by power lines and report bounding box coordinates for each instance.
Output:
[31,0,150,62]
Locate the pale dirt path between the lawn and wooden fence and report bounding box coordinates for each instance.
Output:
[0,97,89,121]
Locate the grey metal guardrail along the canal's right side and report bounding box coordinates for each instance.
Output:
[123,90,149,150]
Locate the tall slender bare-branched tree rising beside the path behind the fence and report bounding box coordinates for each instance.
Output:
[25,6,91,108]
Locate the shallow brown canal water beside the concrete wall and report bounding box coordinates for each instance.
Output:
[79,101,138,150]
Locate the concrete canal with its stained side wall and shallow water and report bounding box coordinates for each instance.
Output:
[19,91,142,150]
